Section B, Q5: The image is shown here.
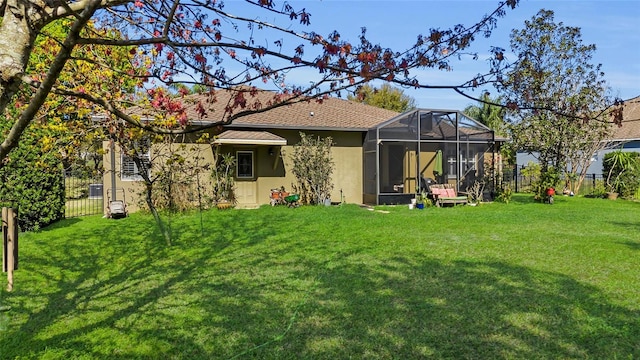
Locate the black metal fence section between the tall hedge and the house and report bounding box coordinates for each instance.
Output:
[64,167,104,218]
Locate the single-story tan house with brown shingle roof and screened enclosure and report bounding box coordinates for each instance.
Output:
[104,88,501,210]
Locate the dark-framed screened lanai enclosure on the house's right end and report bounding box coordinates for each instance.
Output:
[364,109,499,204]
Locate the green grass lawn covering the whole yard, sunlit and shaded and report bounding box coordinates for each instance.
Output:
[0,195,640,359]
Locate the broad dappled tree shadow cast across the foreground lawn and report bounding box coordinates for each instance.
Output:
[0,207,640,359]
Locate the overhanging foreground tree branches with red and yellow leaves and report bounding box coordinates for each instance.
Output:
[0,0,518,166]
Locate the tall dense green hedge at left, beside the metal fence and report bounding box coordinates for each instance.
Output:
[0,119,65,231]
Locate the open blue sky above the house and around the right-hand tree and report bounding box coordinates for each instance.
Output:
[227,0,640,109]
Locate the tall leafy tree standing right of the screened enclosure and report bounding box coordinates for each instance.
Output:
[497,9,612,195]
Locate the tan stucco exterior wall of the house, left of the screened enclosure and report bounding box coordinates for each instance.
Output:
[103,130,363,212]
